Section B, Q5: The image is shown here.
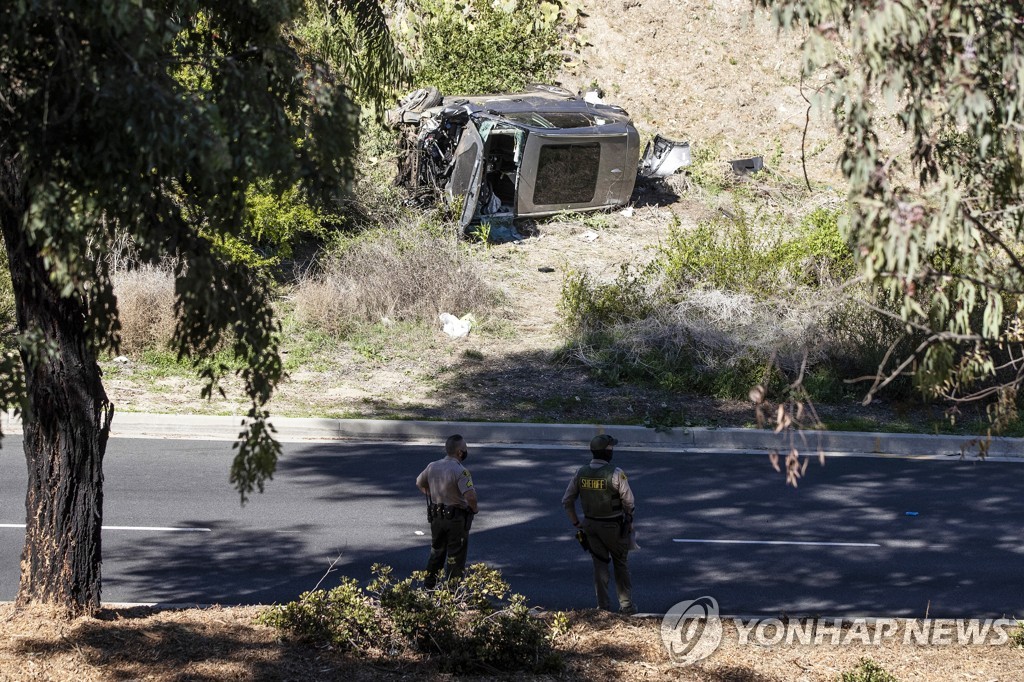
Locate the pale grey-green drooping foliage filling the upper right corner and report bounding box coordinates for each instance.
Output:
[767,0,1024,416]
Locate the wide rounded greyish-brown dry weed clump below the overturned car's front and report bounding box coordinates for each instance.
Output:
[295,228,497,333]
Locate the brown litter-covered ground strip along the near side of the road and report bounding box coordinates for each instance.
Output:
[0,606,1024,682]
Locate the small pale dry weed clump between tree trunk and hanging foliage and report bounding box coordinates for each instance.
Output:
[114,266,175,355]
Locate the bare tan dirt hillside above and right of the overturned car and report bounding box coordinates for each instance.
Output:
[561,0,839,182]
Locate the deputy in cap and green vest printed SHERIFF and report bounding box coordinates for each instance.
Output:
[562,433,637,615]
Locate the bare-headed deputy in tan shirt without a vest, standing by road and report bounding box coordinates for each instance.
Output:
[416,433,476,589]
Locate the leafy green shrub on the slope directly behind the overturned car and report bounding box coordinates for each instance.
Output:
[396,0,562,94]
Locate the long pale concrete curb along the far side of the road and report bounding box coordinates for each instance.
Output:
[8,413,1024,458]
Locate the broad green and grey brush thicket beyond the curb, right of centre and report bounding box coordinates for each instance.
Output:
[559,206,914,401]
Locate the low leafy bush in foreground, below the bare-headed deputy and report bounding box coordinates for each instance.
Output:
[260,564,566,673]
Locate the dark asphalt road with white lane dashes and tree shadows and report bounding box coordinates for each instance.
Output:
[0,436,1024,617]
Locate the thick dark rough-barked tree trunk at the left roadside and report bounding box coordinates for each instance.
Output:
[0,150,114,616]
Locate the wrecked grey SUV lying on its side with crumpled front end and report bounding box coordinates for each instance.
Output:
[387,85,690,227]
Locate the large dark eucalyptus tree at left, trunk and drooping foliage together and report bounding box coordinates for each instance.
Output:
[0,0,397,614]
